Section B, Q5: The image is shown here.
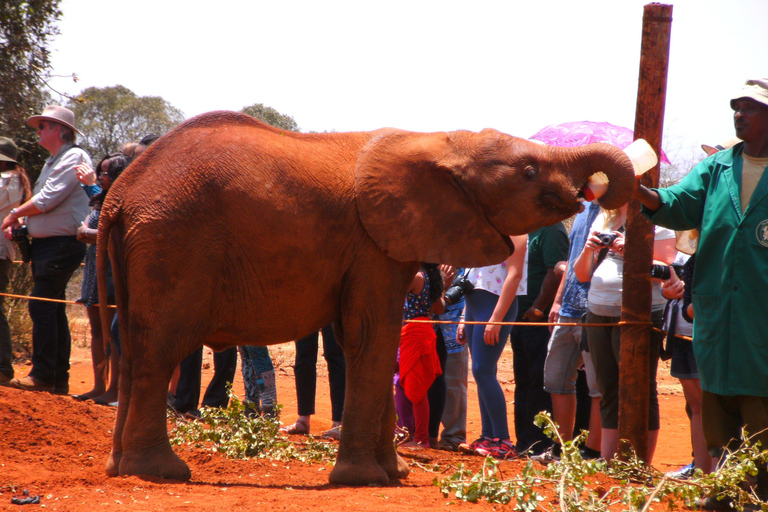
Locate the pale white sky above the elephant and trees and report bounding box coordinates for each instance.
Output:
[50,0,768,163]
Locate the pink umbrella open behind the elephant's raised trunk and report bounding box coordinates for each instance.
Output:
[531,121,670,164]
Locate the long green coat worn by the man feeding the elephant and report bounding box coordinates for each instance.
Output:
[643,144,768,397]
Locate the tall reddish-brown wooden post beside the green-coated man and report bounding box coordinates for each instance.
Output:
[619,4,672,461]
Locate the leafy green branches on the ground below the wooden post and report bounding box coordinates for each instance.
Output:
[434,413,768,512]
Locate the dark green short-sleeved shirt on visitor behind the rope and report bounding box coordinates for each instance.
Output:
[517,222,568,320]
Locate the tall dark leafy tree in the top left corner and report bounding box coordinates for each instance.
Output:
[0,0,61,176]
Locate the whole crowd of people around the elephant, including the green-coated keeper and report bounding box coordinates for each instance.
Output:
[0,79,768,505]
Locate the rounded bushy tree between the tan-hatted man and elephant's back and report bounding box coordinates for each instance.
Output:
[67,85,184,159]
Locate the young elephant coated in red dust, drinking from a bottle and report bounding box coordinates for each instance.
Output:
[99,112,634,484]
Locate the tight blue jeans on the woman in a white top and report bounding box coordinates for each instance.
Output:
[465,290,517,439]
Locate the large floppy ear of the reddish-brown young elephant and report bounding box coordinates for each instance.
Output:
[355,130,514,267]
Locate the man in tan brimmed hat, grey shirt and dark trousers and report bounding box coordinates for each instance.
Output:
[2,105,91,394]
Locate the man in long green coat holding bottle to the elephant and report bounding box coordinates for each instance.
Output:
[636,78,768,495]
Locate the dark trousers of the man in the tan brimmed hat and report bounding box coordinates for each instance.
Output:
[29,236,85,387]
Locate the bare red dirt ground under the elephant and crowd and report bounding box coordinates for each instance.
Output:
[0,344,691,512]
